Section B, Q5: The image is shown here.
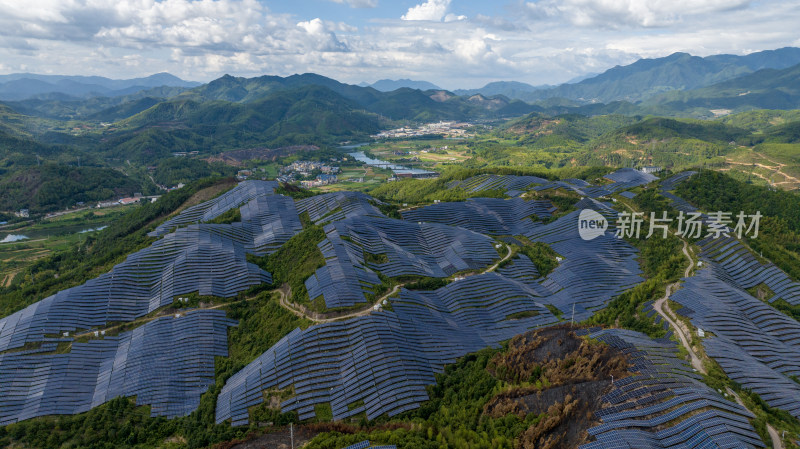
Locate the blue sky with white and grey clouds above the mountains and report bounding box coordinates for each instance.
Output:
[0,0,800,89]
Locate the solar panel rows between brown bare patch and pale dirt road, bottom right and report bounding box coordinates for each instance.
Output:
[581,329,764,449]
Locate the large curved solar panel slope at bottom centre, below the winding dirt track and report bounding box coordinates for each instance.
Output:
[217,273,557,425]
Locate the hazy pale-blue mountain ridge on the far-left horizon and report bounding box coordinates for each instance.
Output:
[0,73,201,101]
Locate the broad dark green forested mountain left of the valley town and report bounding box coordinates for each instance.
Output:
[98,86,380,163]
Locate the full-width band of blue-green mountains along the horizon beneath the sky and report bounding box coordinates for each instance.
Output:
[0,48,800,166]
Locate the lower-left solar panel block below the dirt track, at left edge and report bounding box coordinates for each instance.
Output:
[0,310,236,425]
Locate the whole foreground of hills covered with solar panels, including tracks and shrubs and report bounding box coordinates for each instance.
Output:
[0,168,800,449]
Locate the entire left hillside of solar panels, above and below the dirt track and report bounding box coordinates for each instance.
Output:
[0,181,302,422]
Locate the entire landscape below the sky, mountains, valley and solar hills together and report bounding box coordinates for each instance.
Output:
[0,48,800,449]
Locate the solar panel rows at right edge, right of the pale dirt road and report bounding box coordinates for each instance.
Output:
[648,178,800,417]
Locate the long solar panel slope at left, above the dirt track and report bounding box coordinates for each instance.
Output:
[0,227,272,351]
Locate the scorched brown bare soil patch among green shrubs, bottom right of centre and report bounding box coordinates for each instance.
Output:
[484,325,630,449]
